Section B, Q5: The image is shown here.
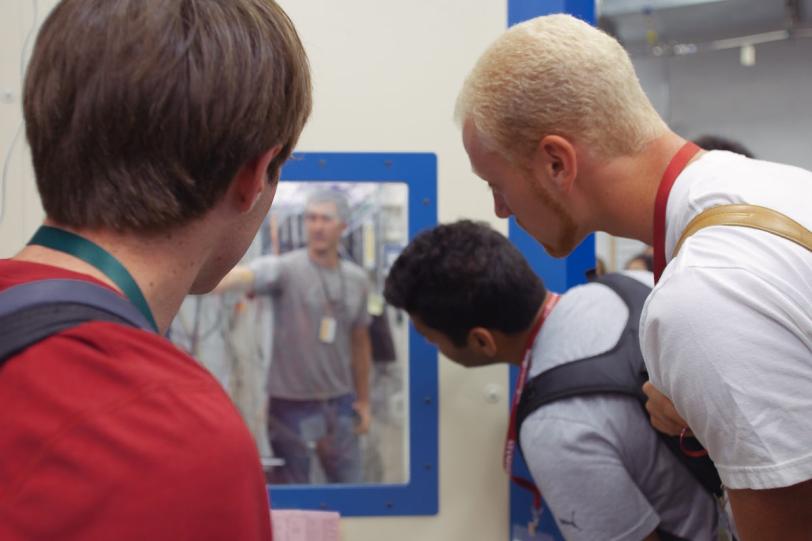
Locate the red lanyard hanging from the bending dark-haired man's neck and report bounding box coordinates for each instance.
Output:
[503,293,561,541]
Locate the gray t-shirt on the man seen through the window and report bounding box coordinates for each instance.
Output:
[250,249,369,400]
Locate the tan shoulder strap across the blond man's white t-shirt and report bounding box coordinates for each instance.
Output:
[672,205,812,257]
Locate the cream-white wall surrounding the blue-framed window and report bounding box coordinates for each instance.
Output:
[0,0,508,541]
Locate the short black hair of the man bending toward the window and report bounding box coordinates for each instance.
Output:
[384,220,546,347]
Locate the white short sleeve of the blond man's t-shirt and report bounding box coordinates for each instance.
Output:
[640,267,812,489]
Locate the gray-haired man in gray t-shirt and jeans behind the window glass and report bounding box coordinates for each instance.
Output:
[216,189,371,484]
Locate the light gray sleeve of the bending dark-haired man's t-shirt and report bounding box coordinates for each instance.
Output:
[521,410,660,541]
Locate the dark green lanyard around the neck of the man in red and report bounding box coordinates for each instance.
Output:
[28,225,159,332]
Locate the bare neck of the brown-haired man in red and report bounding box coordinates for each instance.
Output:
[14,221,208,334]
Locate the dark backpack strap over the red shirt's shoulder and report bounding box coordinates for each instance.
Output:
[0,280,151,366]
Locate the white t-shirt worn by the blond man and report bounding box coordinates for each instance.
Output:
[640,151,812,489]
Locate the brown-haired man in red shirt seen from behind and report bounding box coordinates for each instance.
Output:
[0,0,311,540]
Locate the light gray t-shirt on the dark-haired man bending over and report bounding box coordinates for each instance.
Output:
[520,271,717,541]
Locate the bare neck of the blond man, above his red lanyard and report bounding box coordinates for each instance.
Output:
[585,132,699,244]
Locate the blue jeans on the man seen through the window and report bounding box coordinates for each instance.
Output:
[268,394,362,484]
